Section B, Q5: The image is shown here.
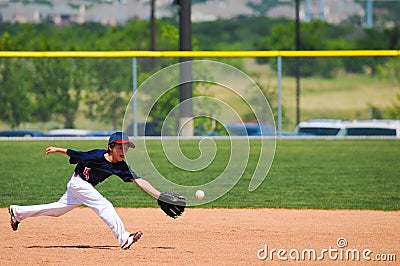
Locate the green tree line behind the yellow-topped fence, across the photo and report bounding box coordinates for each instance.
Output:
[0,17,400,128]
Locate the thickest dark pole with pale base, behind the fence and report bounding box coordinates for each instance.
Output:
[174,0,193,136]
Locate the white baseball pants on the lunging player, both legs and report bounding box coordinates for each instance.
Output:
[12,176,129,246]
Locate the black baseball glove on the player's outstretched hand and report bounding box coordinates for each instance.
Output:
[157,192,186,219]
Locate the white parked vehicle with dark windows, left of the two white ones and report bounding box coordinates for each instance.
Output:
[295,119,348,136]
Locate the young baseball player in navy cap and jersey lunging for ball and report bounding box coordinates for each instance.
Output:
[8,132,186,249]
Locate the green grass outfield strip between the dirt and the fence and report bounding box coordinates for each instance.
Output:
[0,140,400,210]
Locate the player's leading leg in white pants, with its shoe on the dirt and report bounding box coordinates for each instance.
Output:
[67,177,141,247]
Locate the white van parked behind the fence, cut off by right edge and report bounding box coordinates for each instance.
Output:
[338,119,400,138]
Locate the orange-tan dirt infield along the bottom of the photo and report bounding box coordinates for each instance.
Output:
[0,208,400,265]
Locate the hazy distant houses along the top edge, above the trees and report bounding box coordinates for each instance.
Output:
[0,0,365,24]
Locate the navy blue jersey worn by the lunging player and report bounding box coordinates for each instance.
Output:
[67,149,139,186]
